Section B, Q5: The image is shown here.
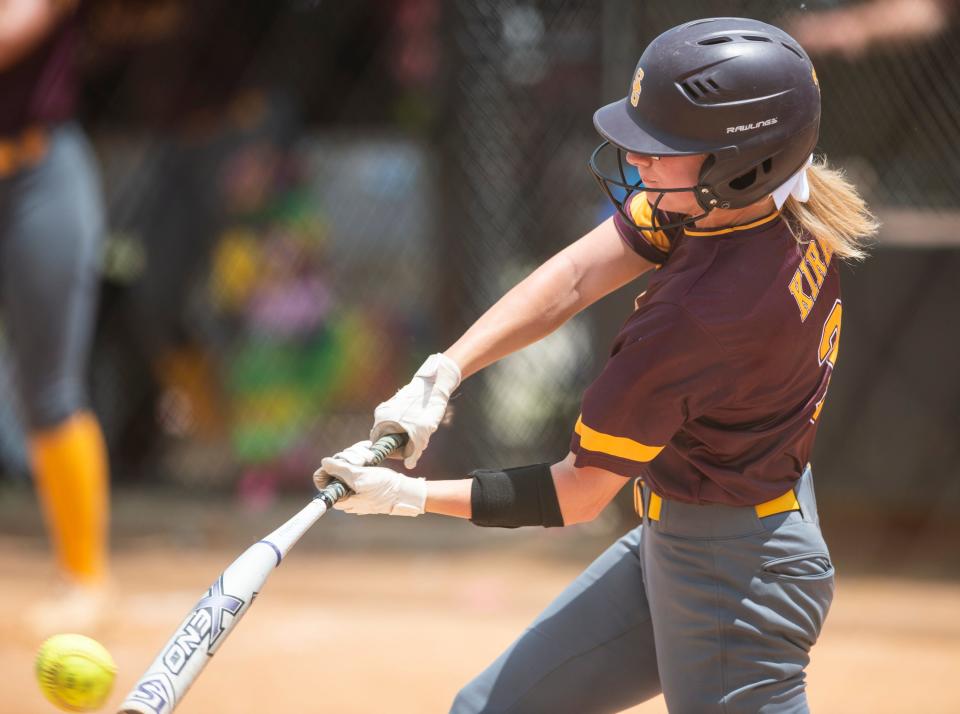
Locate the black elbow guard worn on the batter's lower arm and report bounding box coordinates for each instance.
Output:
[470,464,563,528]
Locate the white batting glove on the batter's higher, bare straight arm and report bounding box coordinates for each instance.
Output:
[370,353,461,469]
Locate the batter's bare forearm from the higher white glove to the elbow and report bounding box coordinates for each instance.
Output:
[446,253,585,378]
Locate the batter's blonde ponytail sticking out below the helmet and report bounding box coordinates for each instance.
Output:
[783,158,880,260]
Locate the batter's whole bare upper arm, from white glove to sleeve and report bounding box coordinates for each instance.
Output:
[445,218,653,378]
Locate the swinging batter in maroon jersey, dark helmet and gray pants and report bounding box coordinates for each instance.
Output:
[316,18,876,714]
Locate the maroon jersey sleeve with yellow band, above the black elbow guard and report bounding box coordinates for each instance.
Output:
[570,303,732,477]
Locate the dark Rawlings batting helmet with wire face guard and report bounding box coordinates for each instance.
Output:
[590,17,820,230]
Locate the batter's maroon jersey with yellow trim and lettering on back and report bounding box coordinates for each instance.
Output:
[571,194,841,506]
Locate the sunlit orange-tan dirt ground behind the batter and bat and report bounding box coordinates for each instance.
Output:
[0,490,960,714]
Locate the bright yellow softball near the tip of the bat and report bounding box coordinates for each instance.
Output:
[37,635,117,712]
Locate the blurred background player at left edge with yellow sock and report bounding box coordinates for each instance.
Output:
[0,0,109,632]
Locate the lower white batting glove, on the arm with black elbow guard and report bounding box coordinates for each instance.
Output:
[313,441,427,516]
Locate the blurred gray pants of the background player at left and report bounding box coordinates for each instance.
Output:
[0,124,104,429]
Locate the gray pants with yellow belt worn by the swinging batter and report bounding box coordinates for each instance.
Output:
[451,467,833,714]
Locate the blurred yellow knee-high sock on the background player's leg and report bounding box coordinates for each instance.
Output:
[30,412,110,584]
